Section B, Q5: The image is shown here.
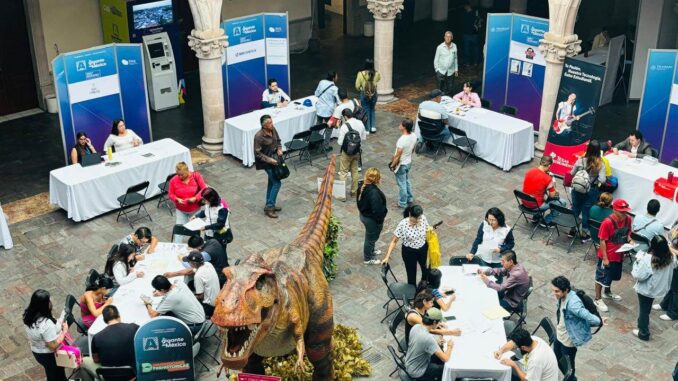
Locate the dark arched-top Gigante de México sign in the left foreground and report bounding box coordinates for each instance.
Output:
[134,316,195,381]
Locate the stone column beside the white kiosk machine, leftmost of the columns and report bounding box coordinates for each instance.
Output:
[188,0,227,154]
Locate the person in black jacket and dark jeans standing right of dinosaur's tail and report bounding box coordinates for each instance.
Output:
[356,168,388,265]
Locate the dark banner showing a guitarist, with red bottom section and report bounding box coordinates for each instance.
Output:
[544,58,605,176]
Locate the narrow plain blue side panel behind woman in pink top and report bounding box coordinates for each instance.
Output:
[482,14,513,111]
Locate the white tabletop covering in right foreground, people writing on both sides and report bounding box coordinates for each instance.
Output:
[439,266,511,381]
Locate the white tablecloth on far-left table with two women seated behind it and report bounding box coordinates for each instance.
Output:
[49,139,193,221]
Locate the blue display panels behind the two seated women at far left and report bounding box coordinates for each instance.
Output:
[52,44,152,164]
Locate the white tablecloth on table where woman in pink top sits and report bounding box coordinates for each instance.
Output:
[416,101,534,171]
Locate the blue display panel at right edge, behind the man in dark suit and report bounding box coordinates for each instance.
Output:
[636,49,678,163]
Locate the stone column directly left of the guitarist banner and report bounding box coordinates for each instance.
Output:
[535,0,581,151]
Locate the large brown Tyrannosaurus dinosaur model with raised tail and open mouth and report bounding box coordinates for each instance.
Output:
[212,157,336,381]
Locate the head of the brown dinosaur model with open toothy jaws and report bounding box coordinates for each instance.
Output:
[212,255,280,369]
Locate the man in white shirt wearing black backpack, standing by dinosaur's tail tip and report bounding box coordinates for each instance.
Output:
[337,108,367,197]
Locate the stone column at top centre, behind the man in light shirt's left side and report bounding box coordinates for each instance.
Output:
[367,0,404,103]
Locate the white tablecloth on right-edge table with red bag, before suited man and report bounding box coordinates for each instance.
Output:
[607,154,678,227]
